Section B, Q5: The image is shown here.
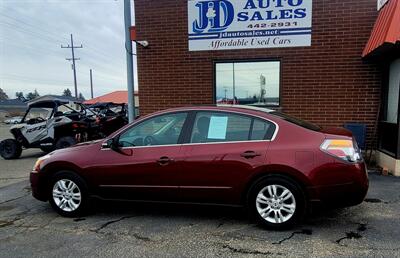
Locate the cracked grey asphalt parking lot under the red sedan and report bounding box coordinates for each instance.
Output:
[0,125,400,257]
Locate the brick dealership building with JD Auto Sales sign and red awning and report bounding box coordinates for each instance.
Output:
[135,0,400,175]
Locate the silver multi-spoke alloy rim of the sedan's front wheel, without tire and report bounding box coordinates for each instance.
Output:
[53,179,82,212]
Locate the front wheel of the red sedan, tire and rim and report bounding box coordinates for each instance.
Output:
[49,171,89,217]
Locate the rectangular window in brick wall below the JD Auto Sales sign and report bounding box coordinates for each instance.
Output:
[215,61,280,106]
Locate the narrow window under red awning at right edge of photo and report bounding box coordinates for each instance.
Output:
[386,59,400,124]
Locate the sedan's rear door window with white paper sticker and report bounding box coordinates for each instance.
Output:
[191,112,252,143]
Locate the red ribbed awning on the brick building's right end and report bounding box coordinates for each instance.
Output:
[362,0,400,57]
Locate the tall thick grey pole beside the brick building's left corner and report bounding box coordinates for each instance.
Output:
[124,0,136,123]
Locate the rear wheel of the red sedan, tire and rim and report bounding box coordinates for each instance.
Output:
[248,175,306,230]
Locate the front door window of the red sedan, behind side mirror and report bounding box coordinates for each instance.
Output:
[119,113,187,147]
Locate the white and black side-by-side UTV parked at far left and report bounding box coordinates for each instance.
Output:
[0,99,104,159]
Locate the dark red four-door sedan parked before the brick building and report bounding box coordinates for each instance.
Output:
[30,106,368,228]
